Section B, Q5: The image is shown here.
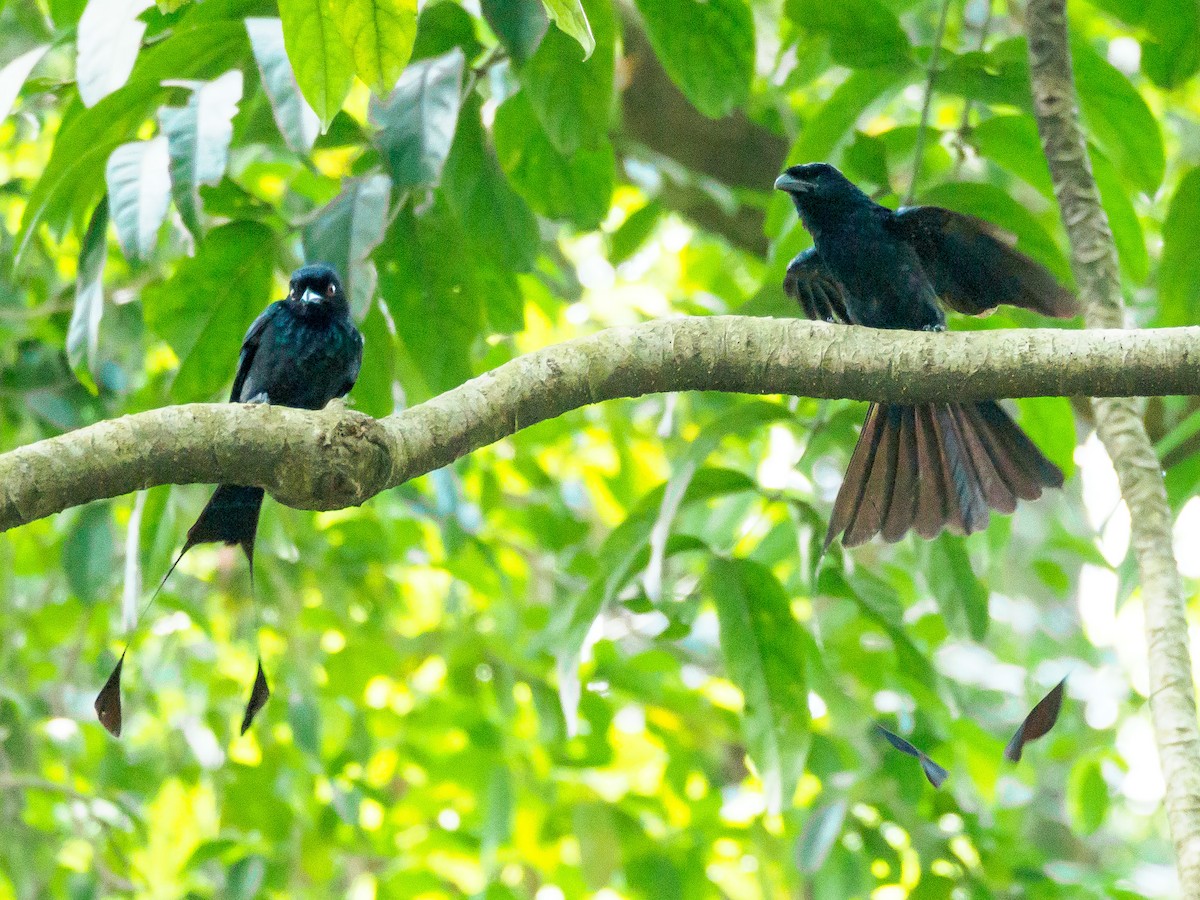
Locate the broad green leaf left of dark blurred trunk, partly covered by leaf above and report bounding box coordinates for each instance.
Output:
[492,92,617,229]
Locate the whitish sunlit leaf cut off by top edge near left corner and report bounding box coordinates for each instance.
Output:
[76,0,154,107]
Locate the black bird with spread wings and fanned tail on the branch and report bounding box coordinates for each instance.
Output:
[775,162,1079,550]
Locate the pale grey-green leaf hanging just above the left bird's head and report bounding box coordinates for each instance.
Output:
[304,175,391,319]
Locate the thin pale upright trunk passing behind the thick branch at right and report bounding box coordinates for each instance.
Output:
[1026,0,1200,900]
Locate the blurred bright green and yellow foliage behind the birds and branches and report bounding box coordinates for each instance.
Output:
[0,0,1200,900]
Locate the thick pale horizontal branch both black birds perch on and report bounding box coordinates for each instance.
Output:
[0,316,1200,530]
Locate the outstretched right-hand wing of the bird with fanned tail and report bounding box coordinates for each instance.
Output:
[888,206,1079,319]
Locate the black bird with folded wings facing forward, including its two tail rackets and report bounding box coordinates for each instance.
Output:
[96,264,362,734]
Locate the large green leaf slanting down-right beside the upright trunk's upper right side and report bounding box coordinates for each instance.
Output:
[1070,40,1166,196]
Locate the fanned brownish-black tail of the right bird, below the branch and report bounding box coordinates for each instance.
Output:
[824,401,1063,550]
